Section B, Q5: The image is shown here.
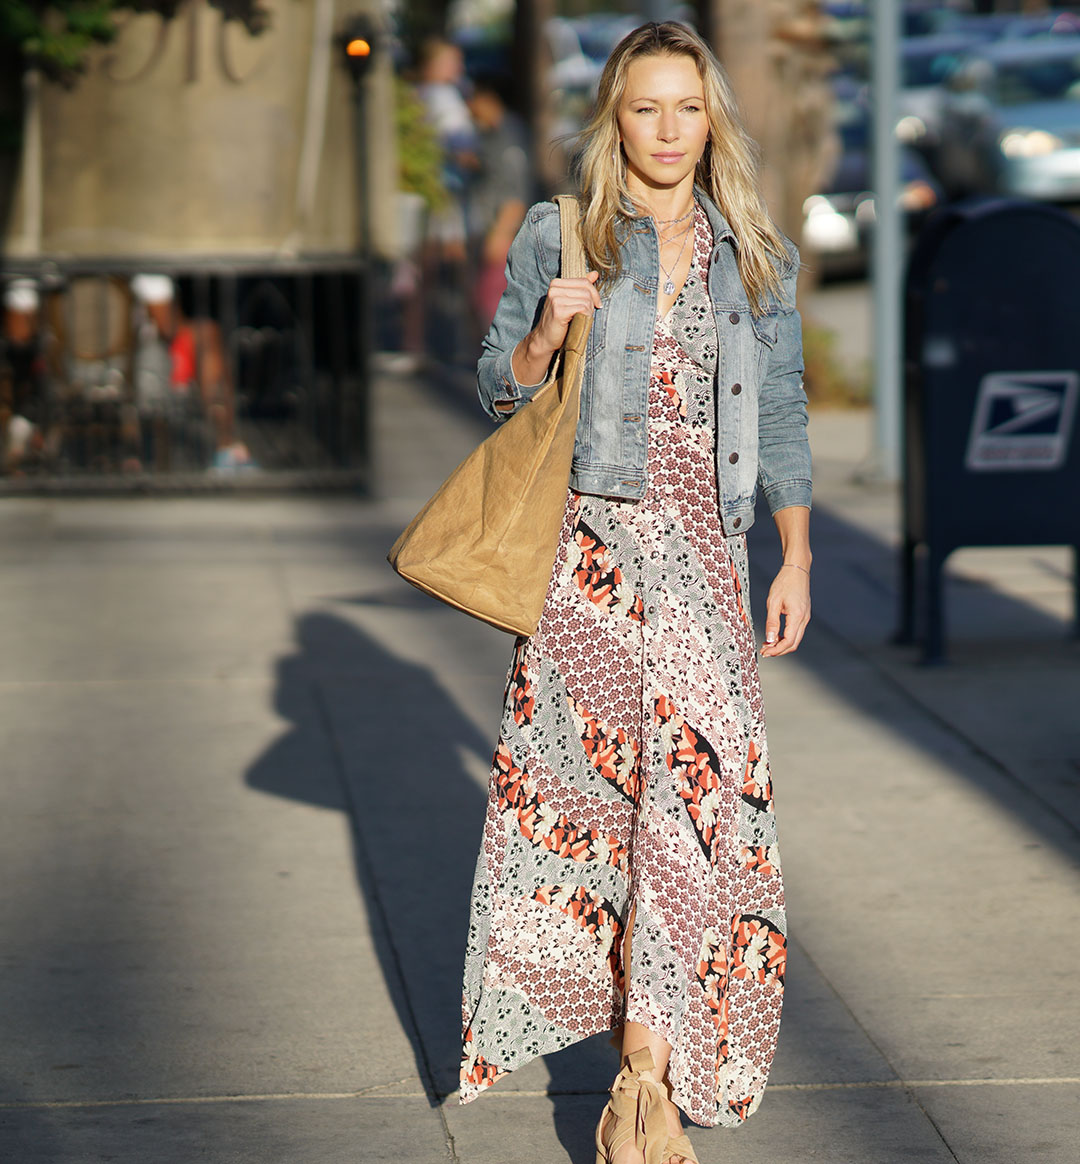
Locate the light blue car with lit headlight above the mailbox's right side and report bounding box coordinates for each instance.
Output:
[937,36,1080,203]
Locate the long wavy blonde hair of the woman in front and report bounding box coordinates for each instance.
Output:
[576,21,789,315]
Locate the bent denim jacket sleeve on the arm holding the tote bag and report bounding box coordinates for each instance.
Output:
[476,203,560,420]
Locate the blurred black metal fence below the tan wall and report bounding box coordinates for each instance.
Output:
[0,258,372,492]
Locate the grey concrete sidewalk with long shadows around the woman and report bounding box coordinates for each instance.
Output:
[0,365,1080,1164]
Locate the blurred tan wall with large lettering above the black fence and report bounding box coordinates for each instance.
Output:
[3,0,397,256]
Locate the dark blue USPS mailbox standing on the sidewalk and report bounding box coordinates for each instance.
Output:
[897,199,1080,661]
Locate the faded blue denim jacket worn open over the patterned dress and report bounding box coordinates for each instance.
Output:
[477,190,810,535]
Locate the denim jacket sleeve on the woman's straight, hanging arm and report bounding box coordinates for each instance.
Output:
[758,240,812,513]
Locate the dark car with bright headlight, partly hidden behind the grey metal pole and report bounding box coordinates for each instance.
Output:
[802,78,943,276]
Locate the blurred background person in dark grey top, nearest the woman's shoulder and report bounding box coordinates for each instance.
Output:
[468,76,533,335]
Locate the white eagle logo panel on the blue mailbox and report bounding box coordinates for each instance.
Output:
[964,371,1080,473]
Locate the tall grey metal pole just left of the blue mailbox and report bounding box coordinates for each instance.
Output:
[871,0,904,481]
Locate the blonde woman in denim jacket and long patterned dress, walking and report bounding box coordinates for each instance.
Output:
[461,23,810,1164]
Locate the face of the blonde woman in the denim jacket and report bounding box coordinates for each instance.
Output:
[616,55,709,197]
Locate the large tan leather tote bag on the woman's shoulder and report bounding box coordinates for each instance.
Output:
[388,196,592,636]
